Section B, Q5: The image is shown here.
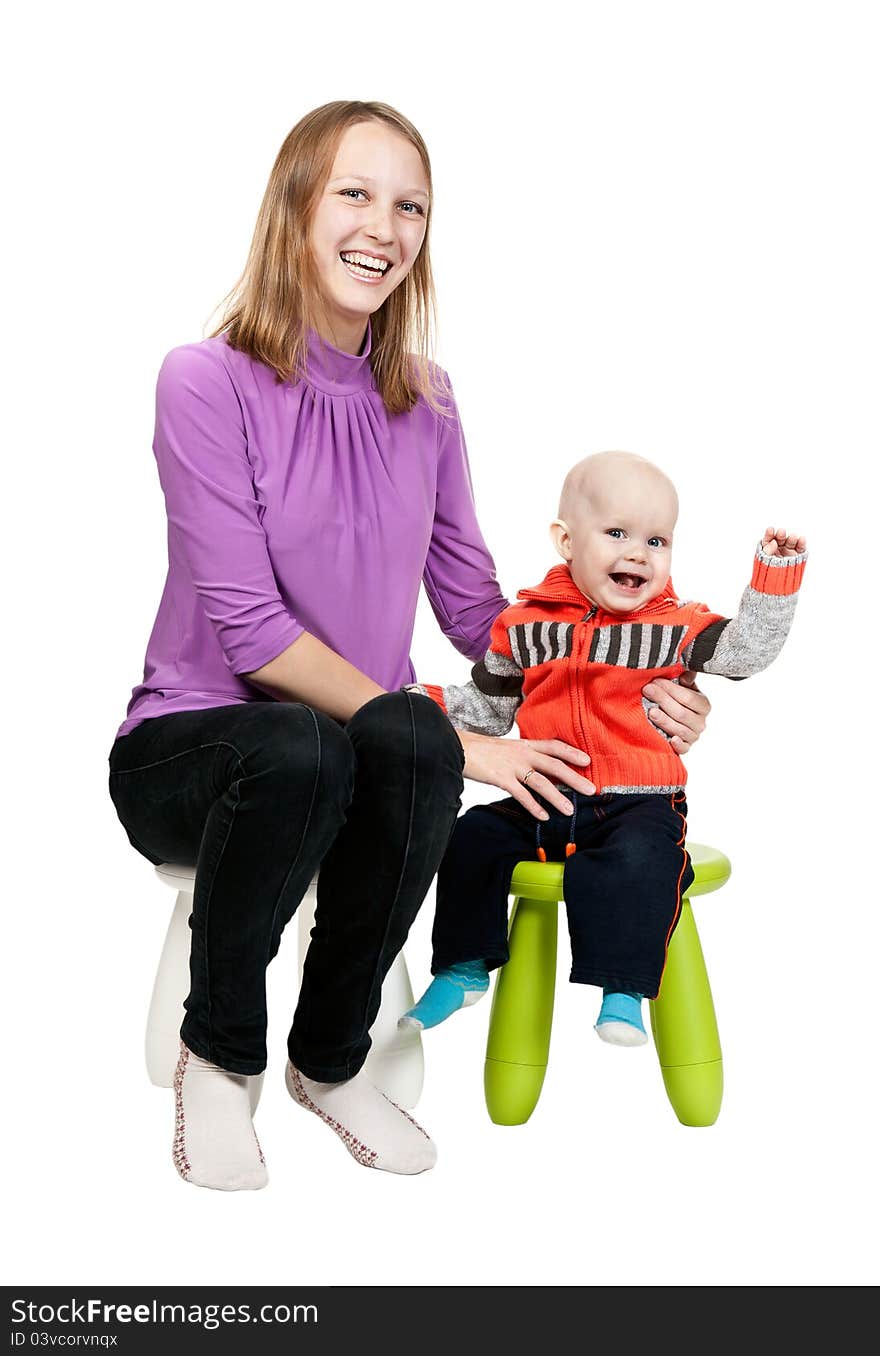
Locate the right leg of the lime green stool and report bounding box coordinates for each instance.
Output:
[649,899,724,1125]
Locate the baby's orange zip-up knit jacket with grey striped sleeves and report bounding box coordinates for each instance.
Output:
[409,546,807,793]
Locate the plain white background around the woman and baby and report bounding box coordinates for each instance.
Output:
[3,0,880,1285]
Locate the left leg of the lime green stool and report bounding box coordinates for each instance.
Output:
[483,896,559,1125]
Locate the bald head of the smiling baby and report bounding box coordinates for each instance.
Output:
[551,452,678,612]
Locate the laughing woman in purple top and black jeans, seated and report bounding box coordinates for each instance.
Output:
[110,102,708,1191]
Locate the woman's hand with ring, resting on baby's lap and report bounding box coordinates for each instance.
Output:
[456,737,591,819]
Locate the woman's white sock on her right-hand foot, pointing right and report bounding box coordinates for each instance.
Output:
[285,1060,437,1176]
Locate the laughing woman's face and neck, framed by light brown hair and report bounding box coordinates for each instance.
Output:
[311,122,428,353]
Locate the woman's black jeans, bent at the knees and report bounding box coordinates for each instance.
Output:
[110,690,464,1082]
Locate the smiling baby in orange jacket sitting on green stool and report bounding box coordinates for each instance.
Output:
[400,452,807,1045]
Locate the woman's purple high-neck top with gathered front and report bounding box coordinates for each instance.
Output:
[117,327,507,735]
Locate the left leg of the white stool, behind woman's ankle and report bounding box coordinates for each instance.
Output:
[145,890,263,1115]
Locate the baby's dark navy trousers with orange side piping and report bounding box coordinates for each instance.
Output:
[431,791,694,998]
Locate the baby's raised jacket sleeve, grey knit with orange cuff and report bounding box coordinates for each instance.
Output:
[682,545,807,678]
